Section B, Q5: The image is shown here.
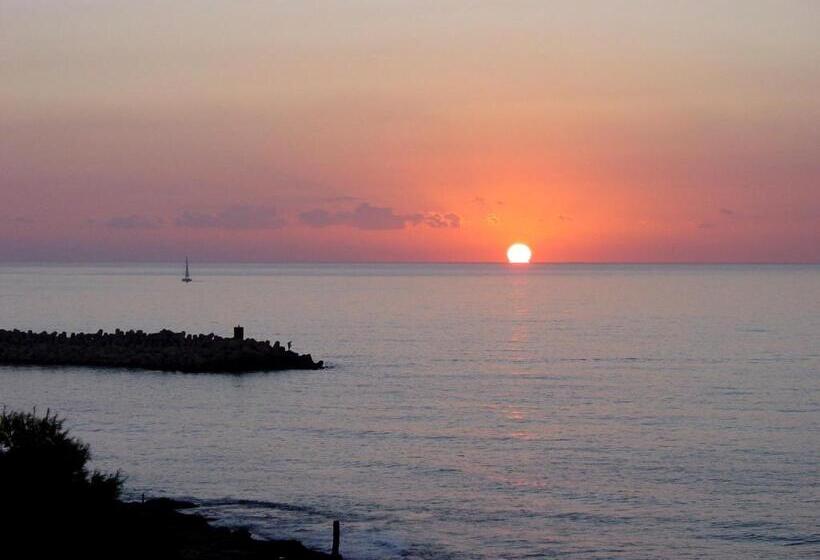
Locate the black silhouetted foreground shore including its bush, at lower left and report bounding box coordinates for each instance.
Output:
[0,411,340,560]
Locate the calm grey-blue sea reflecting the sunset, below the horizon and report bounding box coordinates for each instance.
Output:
[0,265,820,560]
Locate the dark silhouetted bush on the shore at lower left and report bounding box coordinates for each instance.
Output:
[0,409,123,508]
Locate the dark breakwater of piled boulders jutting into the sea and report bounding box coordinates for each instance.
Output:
[0,327,324,373]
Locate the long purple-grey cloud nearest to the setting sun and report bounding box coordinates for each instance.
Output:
[299,202,461,230]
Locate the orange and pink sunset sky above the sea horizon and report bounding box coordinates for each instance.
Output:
[0,0,820,262]
